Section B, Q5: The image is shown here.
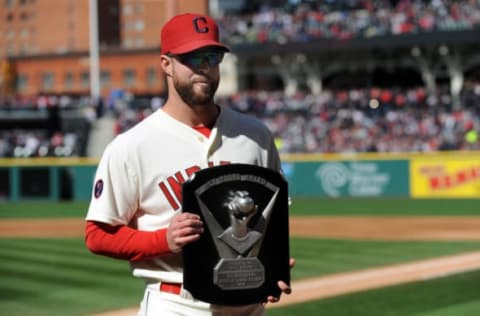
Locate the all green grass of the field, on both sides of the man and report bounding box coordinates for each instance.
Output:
[0,199,480,316]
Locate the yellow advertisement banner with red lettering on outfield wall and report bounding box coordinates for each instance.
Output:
[410,154,480,198]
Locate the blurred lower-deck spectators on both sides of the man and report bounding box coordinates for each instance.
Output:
[0,86,480,157]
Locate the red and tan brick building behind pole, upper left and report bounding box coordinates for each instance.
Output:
[0,0,208,96]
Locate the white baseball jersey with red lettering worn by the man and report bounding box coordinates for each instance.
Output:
[86,108,280,283]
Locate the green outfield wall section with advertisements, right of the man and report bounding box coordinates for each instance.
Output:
[282,151,480,198]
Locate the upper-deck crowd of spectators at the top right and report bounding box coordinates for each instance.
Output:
[218,0,480,45]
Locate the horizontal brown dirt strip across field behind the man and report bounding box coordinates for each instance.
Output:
[0,216,480,240]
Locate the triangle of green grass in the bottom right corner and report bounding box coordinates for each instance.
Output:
[267,271,480,316]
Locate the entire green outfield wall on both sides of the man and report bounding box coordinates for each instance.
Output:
[0,152,480,201]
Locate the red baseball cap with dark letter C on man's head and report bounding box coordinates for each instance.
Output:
[161,13,230,54]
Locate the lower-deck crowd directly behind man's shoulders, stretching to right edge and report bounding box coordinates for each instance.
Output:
[109,83,480,153]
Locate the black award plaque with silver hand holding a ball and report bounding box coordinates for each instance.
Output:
[182,164,290,305]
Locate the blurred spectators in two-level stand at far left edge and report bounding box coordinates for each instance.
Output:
[0,96,97,158]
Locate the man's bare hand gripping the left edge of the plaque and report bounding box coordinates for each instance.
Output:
[167,213,203,253]
